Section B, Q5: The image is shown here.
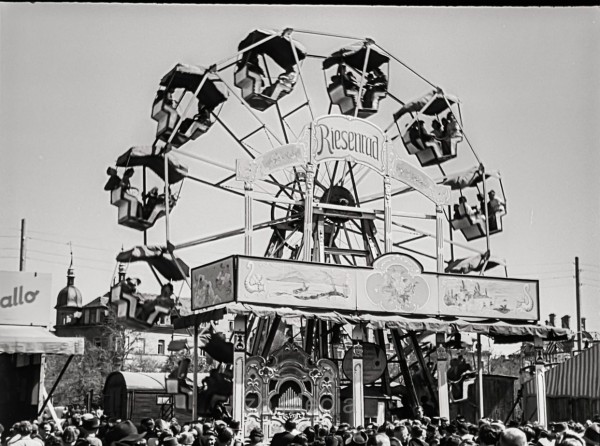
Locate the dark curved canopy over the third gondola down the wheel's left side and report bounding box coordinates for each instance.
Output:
[117,146,188,184]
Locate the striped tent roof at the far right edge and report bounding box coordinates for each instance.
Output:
[546,344,600,398]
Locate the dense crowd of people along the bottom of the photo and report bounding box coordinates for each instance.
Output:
[0,407,600,446]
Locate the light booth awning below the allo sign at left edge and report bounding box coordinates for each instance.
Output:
[0,325,84,355]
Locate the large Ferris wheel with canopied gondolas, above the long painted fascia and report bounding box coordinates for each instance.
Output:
[105,29,506,327]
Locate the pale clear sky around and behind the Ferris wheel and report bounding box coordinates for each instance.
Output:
[0,3,600,350]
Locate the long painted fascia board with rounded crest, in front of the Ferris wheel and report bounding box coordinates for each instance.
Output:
[192,253,539,320]
